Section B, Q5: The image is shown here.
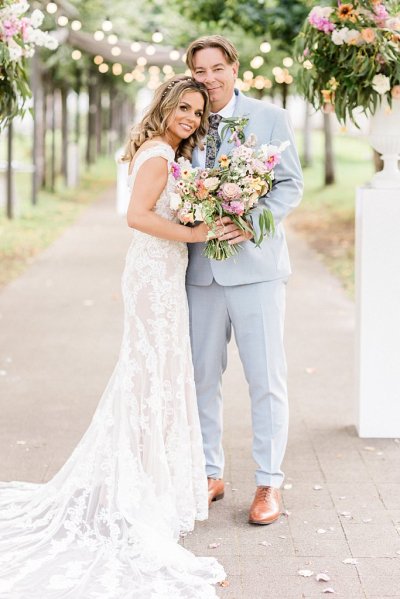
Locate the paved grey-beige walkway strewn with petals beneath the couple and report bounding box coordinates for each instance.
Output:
[0,192,400,599]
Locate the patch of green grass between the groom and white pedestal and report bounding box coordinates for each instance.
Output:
[290,131,374,295]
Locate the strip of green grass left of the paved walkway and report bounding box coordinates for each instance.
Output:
[0,157,115,286]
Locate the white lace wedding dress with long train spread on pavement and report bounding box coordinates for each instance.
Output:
[0,143,225,599]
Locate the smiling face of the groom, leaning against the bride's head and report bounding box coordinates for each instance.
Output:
[193,48,239,112]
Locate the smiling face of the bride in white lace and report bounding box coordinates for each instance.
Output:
[167,91,204,140]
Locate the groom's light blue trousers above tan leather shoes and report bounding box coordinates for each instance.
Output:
[187,279,288,488]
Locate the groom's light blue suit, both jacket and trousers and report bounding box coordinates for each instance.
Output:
[186,90,302,487]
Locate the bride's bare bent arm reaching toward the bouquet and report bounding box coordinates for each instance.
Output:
[127,157,209,243]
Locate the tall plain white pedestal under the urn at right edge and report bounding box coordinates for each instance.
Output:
[356,187,400,438]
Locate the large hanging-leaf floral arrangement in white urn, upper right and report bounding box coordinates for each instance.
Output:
[296,0,400,122]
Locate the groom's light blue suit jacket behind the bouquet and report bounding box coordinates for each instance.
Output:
[186,90,303,286]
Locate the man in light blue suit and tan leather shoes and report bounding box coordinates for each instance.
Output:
[186,35,302,524]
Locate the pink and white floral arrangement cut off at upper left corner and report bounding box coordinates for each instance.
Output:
[0,0,58,127]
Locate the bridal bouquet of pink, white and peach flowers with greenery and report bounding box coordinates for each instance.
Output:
[170,135,289,260]
